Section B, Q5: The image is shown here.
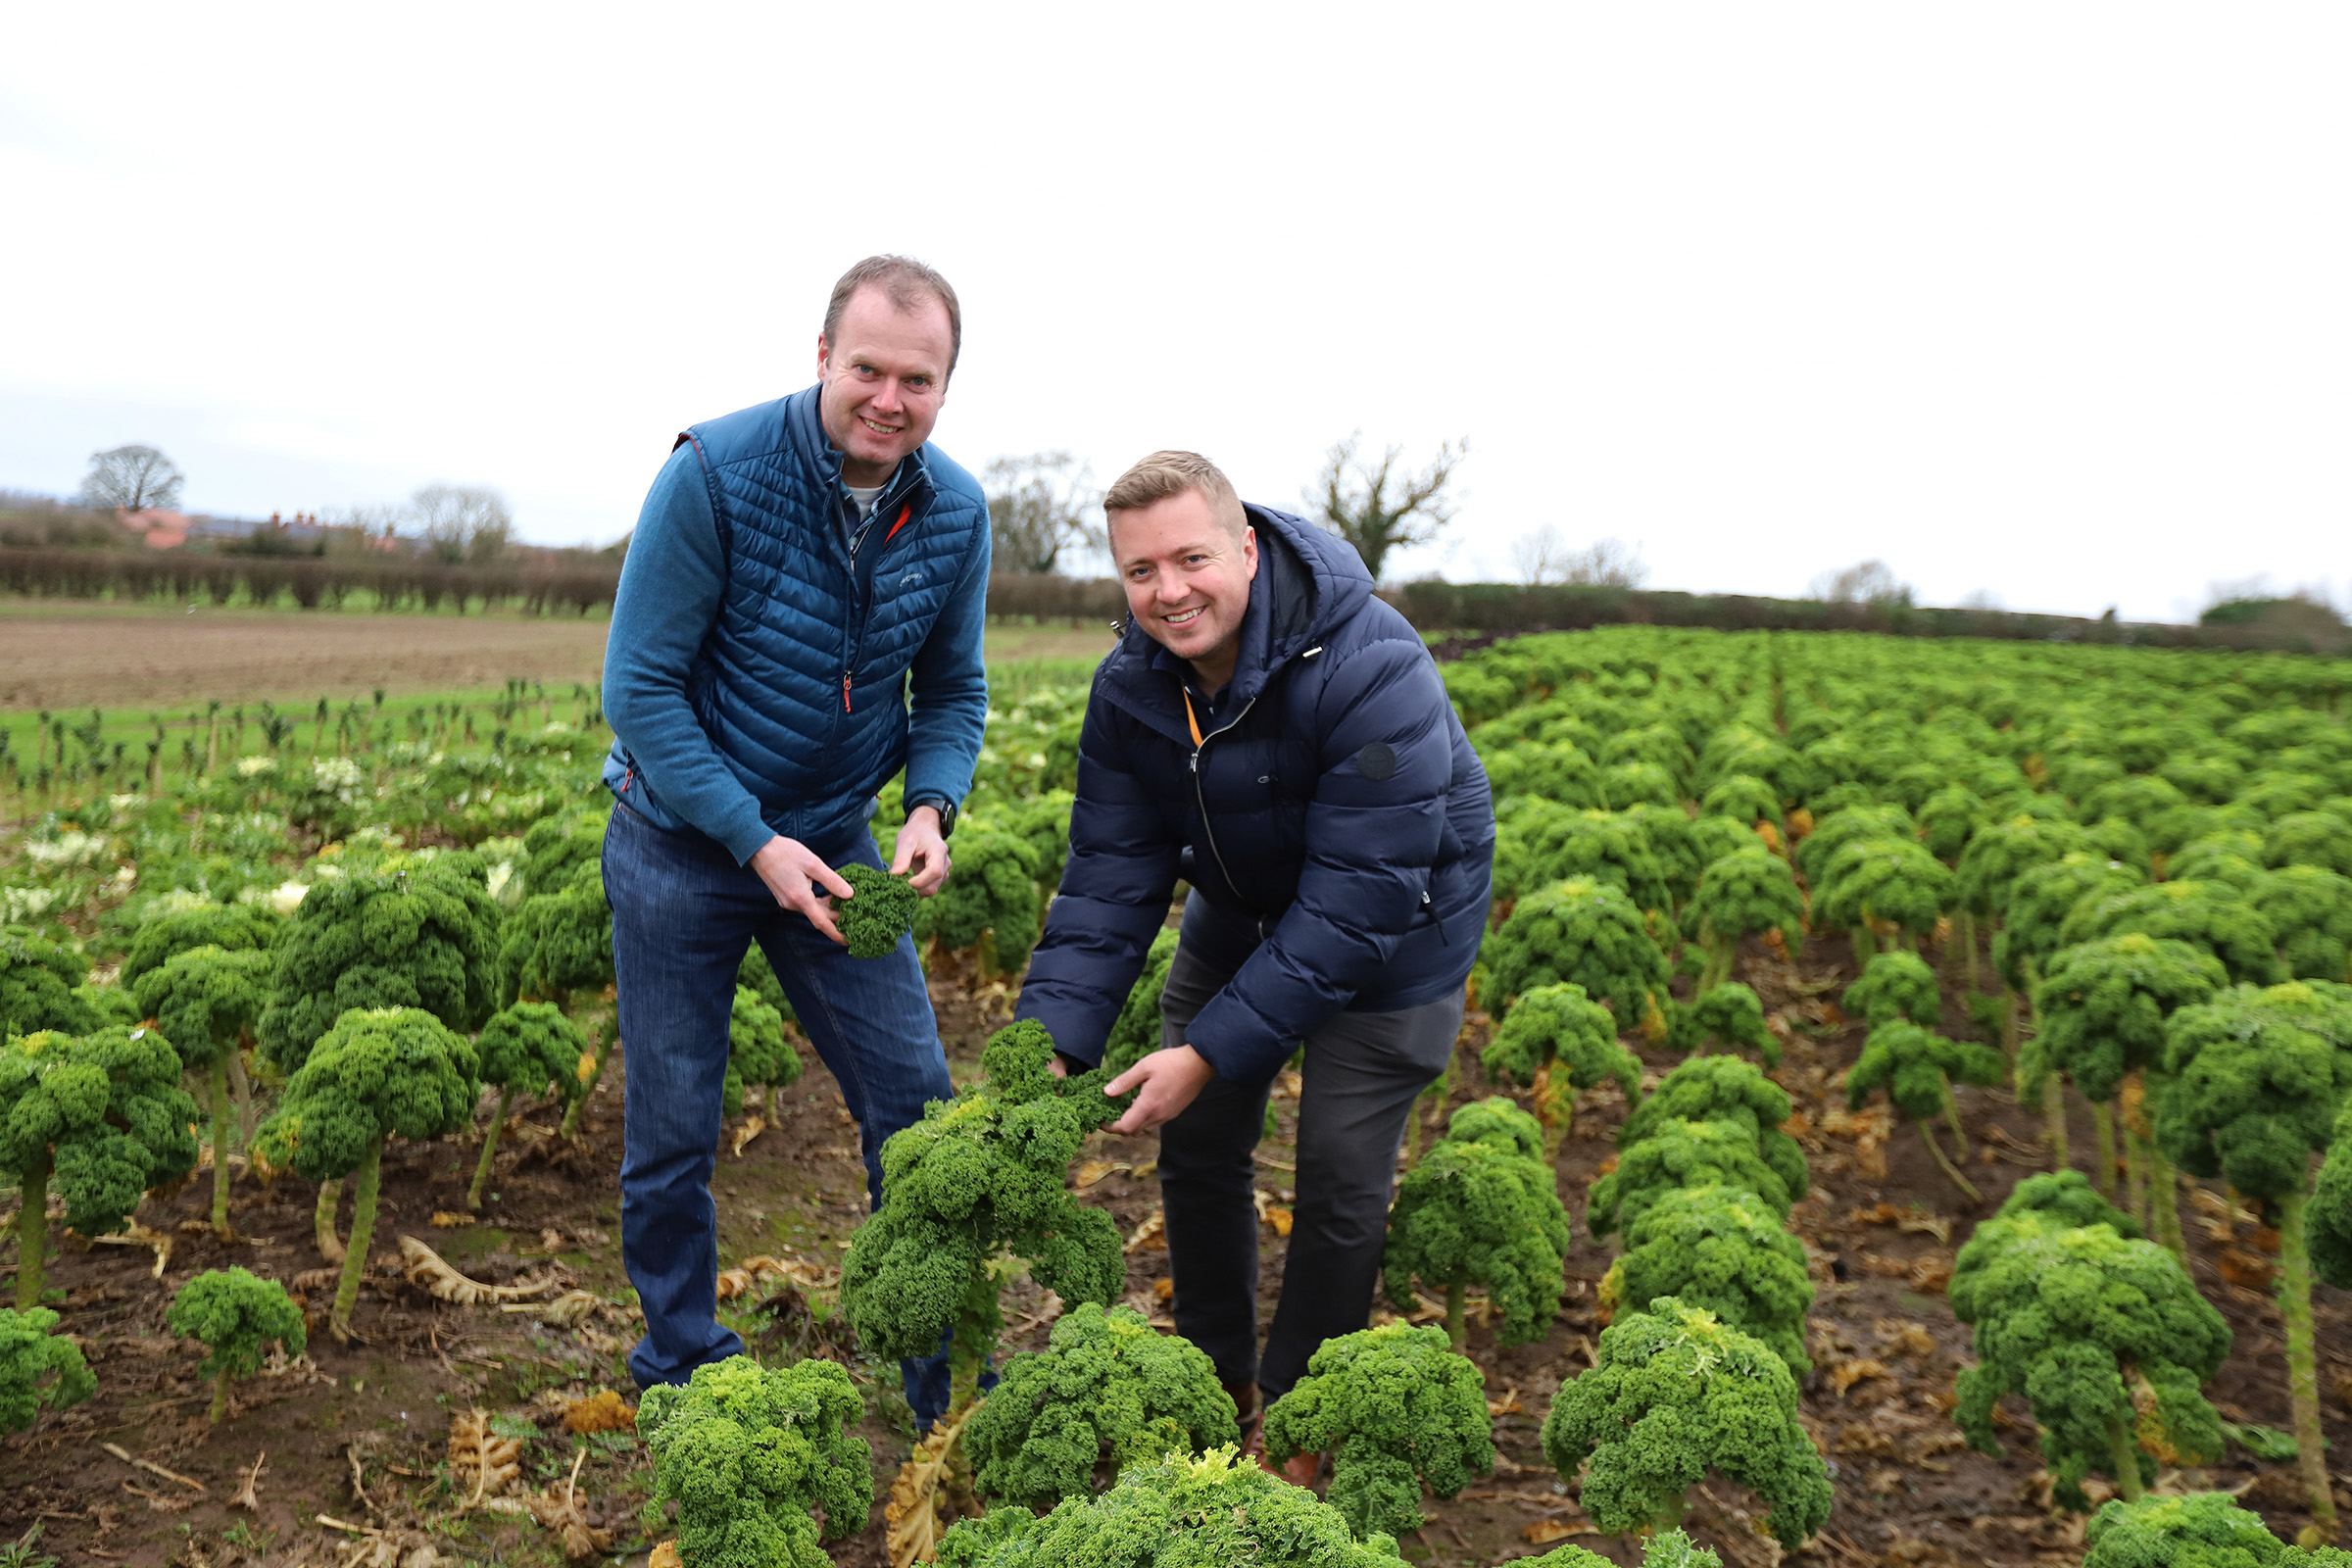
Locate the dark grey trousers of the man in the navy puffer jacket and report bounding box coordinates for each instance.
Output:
[1159,941,1463,1401]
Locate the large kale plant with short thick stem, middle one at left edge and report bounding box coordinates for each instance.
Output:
[0,1025,195,1309]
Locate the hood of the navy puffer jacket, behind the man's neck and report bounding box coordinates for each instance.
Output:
[1103,501,1371,714]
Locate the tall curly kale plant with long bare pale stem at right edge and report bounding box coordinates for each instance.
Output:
[2157,980,2352,1533]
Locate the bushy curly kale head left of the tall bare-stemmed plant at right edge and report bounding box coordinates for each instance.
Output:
[1952,1225,2230,1509]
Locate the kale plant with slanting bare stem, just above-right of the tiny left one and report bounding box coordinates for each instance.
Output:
[254,1006,480,1340]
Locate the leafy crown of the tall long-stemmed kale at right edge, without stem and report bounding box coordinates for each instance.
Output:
[2154,980,2352,1201]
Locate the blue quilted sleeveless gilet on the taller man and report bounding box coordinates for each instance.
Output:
[625,385,988,844]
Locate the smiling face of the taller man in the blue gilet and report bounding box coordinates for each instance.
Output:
[816,287,955,489]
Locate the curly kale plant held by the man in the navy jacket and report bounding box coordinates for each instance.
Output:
[842,1020,1127,1408]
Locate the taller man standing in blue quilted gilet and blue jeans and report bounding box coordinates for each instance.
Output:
[605,256,988,1420]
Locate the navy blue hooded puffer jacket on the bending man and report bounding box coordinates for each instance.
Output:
[1018,506,1494,1081]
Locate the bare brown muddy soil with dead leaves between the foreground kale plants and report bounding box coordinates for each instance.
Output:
[0,921,2352,1568]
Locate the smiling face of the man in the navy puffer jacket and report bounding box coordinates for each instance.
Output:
[1110,489,1258,691]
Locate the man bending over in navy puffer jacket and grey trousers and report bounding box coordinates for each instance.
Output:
[1018,452,1494,1457]
